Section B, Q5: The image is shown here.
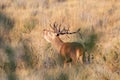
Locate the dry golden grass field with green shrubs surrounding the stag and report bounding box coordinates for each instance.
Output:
[0,0,120,80]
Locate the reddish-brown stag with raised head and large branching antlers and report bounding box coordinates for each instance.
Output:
[43,23,85,66]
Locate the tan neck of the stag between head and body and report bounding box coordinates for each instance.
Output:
[52,36,64,52]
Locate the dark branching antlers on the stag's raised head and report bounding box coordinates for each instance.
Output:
[50,22,80,36]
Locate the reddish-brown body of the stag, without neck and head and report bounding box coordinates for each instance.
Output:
[60,42,84,64]
